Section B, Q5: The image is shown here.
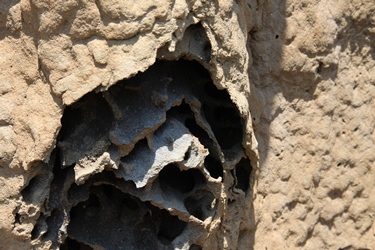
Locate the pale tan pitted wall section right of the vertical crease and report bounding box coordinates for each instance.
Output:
[253,0,375,249]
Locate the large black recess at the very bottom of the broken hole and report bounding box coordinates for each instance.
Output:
[68,185,186,249]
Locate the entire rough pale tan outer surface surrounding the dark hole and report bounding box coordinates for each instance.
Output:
[0,0,375,249]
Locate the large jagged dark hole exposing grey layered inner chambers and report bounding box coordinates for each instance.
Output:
[41,58,251,249]
